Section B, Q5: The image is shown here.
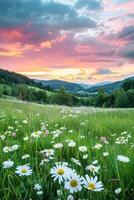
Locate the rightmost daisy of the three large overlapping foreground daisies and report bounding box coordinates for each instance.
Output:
[83,175,104,192]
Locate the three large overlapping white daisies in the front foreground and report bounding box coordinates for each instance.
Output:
[50,163,104,194]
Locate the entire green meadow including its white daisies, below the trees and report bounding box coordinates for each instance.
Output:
[0,99,134,200]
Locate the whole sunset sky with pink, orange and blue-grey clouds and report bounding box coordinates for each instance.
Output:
[0,0,134,83]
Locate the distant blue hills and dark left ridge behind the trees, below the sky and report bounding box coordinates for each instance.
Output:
[0,69,134,95]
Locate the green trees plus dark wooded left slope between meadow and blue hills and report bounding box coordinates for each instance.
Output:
[0,69,134,108]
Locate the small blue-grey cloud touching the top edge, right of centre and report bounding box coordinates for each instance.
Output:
[75,0,102,10]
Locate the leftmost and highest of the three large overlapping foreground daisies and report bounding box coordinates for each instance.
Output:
[50,164,70,184]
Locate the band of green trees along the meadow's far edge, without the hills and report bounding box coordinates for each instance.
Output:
[0,80,134,108]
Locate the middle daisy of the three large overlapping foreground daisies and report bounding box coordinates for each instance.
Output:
[65,174,83,194]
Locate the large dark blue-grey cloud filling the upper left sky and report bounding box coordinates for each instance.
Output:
[0,0,96,29]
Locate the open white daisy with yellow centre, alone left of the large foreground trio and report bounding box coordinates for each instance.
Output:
[15,165,32,176]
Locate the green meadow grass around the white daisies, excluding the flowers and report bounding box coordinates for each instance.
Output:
[0,99,134,200]
